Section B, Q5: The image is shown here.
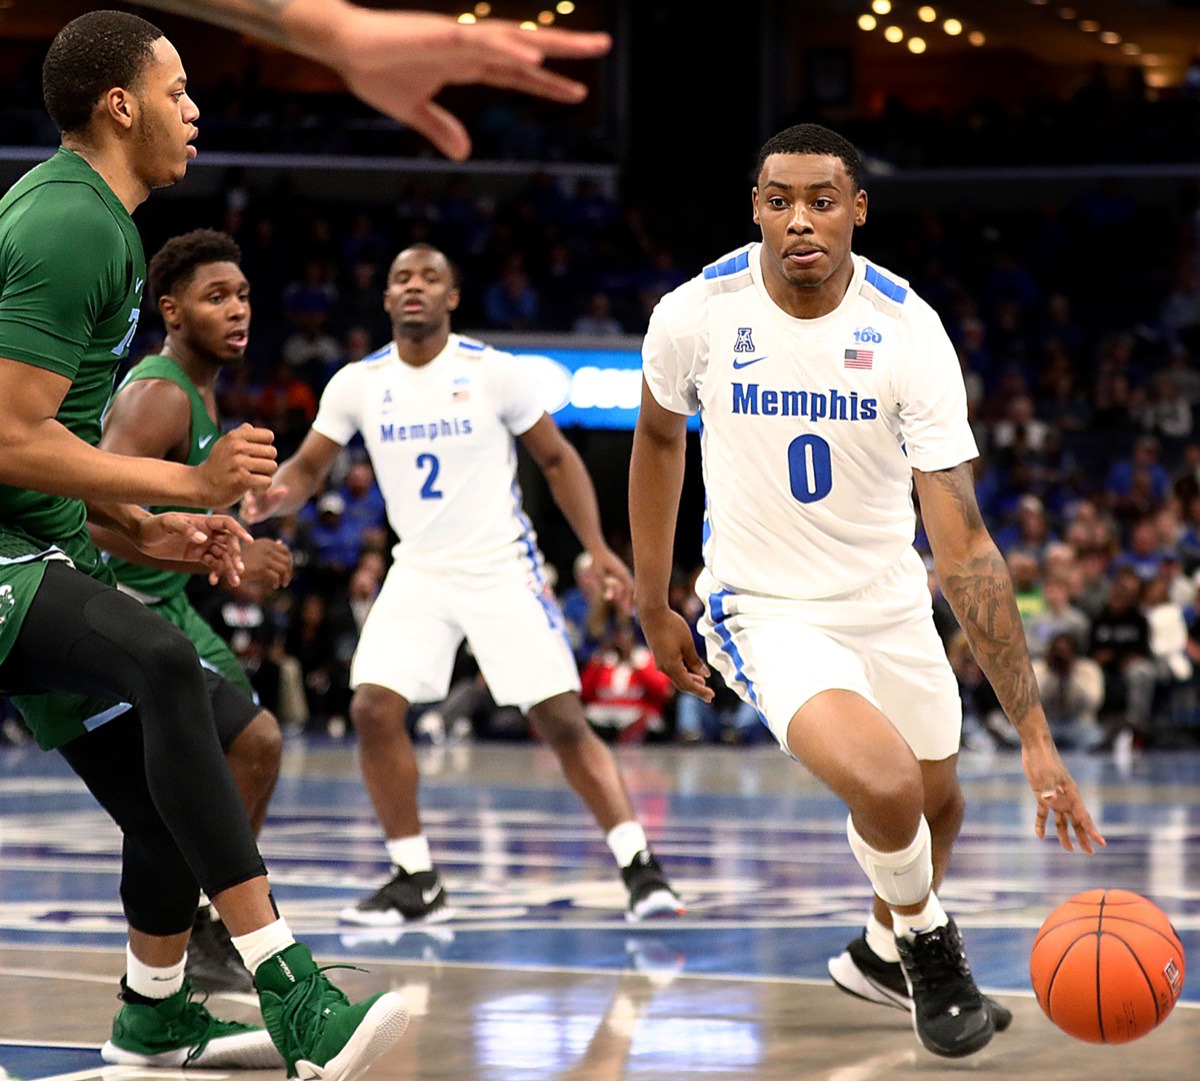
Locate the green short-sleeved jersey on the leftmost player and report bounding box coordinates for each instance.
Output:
[0,148,146,581]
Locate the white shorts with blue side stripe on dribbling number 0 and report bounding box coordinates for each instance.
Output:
[696,548,962,762]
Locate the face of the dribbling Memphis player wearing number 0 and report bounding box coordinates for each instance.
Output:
[754,154,866,289]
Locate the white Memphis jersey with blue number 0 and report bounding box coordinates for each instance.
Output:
[642,244,978,600]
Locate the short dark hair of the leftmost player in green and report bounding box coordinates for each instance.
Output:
[42,11,163,134]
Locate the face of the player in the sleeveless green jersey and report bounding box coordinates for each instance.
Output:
[160,263,250,364]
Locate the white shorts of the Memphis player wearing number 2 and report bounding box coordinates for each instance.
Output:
[350,560,580,709]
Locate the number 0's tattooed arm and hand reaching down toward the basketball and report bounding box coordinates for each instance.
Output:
[913,463,1104,852]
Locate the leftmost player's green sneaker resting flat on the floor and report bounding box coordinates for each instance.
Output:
[100,979,283,1070]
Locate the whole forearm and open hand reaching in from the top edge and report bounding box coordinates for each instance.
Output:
[131,0,611,160]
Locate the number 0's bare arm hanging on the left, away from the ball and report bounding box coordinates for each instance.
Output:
[629,379,713,702]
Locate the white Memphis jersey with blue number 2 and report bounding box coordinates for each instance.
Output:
[312,335,544,573]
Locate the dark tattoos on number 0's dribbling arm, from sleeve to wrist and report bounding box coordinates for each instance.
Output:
[928,466,1040,737]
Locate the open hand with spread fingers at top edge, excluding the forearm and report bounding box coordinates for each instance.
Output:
[316,7,612,161]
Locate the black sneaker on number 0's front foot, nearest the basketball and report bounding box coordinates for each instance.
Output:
[896,919,996,1058]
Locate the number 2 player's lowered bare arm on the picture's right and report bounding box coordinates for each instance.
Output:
[520,413,634,609]
